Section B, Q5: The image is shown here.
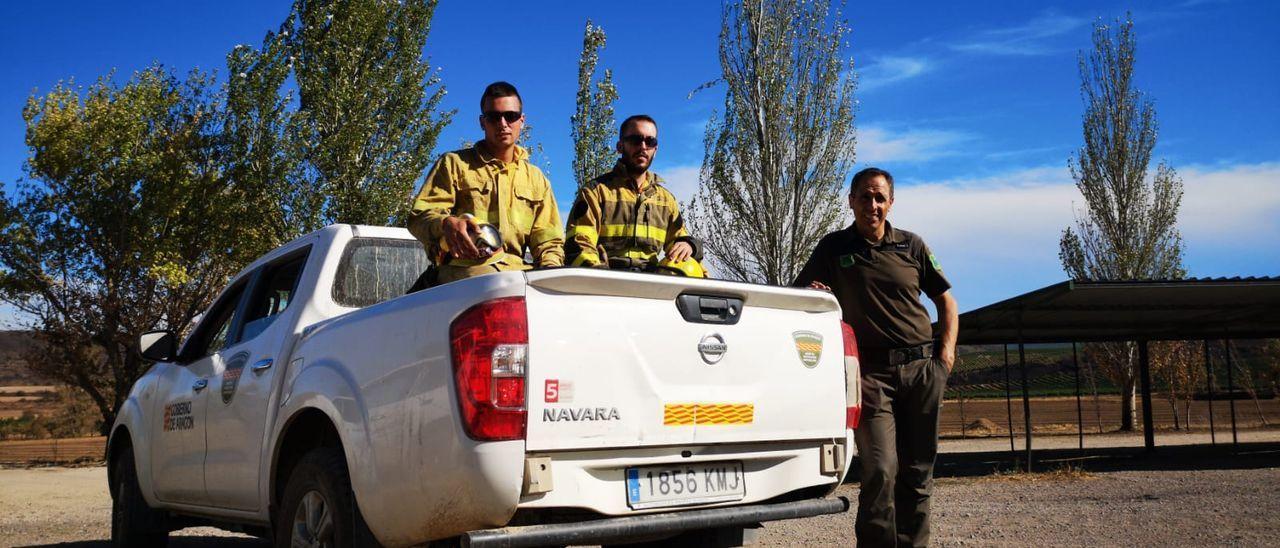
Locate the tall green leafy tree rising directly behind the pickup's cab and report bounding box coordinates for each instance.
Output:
[288,0,452,226]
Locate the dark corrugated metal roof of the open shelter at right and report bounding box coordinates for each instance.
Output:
[934,278,1280,344]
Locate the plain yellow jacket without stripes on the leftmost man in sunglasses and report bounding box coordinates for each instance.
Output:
[408,141,564,270]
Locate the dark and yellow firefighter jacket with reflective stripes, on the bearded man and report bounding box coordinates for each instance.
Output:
[564,161,701,268]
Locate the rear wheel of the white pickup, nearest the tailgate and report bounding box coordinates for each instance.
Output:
[268,447,378,548]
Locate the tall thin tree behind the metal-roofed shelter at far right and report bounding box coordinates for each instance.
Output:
[1059,19,1185,430]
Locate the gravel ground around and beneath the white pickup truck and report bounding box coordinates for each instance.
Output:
[0,435,1280,547]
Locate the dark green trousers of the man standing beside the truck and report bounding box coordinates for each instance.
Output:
[854,359,947,547]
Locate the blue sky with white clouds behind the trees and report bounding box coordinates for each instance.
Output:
[0,0,1280,325]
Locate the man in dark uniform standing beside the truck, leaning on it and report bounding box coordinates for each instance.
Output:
[792,168,960,547]
